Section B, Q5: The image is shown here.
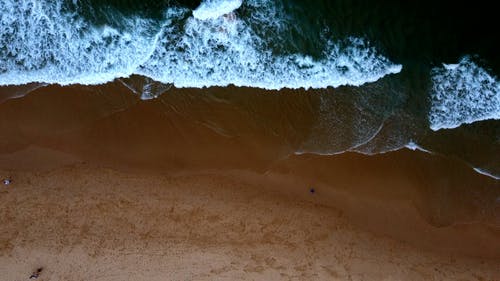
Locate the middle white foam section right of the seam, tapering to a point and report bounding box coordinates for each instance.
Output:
[137,12,401,89]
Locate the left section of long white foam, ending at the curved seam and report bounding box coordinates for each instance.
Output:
[0,0,154,85]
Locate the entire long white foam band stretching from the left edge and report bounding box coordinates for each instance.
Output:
[0,0,401,89]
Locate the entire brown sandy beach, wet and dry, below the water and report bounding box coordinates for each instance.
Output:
[0,85,500,280]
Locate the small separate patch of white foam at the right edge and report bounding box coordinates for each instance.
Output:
[429,57,500,130]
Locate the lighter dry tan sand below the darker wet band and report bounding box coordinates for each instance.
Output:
[0,161,500,281]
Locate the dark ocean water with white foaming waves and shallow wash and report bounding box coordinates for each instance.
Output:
[0,0,500,177]
